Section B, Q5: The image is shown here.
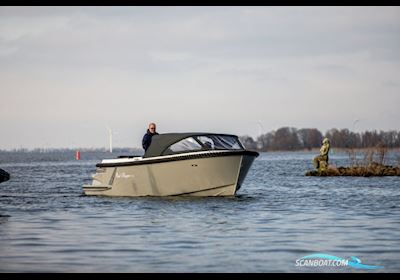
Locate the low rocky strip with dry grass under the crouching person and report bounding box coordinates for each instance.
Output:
[305,163,400,177]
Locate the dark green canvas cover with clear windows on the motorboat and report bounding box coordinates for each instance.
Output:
[143,132,245,158]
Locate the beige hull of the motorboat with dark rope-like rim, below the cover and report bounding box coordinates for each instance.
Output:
[83,152,258,196]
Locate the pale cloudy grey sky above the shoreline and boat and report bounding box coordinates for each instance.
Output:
[0,6,400,150]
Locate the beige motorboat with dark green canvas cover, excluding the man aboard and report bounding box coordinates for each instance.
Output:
[83,133,259,196]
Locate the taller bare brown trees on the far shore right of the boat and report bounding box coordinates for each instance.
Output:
[240,127,400,152]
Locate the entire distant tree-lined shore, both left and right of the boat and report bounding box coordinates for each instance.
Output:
[0,127,400,153]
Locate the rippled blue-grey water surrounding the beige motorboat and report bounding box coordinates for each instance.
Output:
[0,152,400,272]
